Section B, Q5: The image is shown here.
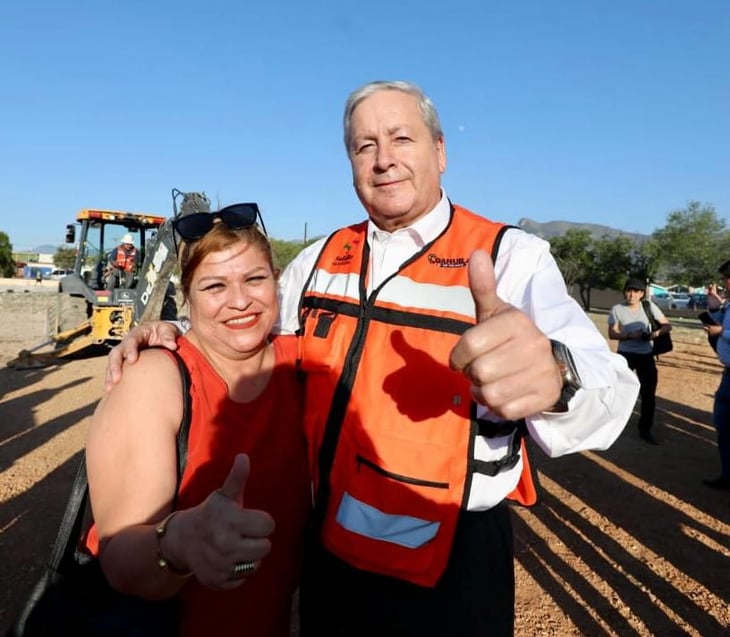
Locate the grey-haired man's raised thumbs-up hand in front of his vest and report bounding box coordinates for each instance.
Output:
[450,250,562,420]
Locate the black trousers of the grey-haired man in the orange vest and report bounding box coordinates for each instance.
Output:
[300,504,515,637]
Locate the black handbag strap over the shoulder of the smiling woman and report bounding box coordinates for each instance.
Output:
[48,350,192,571]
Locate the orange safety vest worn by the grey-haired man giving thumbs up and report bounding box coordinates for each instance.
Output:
[292,206,537,586]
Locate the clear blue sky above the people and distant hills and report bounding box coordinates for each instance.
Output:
[0,0,730,249]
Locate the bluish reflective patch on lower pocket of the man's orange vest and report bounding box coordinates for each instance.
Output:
[336,492,441,549]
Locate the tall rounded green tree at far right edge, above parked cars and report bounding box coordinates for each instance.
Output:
[652,201,730,286]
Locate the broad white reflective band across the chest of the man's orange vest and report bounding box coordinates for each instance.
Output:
[310,269,474,318]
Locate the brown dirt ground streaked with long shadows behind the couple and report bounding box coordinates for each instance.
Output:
[0,283,730,637]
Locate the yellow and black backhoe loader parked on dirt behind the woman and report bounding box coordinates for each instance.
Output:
[8,189,210,369]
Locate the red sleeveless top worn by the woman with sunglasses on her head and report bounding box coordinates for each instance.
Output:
[177,336,311,637]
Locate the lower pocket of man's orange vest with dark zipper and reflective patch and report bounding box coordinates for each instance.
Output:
[322,432,464,586]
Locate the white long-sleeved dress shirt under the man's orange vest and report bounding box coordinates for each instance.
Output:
[280,192,639,510]
